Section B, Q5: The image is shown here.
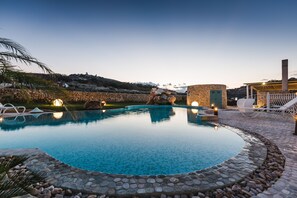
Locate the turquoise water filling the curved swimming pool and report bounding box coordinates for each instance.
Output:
[0,107,245,175]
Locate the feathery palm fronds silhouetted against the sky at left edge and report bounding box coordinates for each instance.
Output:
[0,37,53,75]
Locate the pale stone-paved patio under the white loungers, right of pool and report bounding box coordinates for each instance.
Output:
[219,111,297,198]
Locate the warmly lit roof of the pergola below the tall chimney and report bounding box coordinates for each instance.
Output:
[244,80,297,91]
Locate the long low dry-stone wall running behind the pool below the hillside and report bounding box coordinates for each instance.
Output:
[0,89,186,103]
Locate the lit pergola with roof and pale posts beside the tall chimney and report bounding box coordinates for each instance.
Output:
[244,80,297,98]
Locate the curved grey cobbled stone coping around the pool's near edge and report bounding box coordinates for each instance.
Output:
[0,126,267,197]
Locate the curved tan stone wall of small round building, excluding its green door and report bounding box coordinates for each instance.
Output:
[187,84,227,108]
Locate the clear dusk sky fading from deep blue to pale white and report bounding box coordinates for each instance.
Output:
[0,0,297,88]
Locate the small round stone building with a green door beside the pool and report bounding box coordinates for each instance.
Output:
[187,84,227,109]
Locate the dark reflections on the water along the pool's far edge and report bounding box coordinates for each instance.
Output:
[0,106,209,131]
